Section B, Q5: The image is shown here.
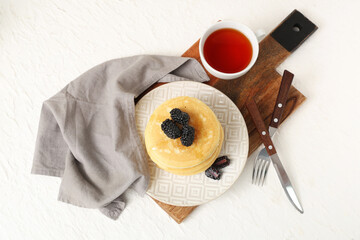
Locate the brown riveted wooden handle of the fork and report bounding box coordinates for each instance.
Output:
[270,70,294,128]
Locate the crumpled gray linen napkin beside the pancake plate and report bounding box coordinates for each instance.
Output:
[31,55,209,219]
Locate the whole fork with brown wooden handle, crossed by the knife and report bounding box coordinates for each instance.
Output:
[252,70,294,186]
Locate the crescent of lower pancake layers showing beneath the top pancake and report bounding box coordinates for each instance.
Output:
[153,127,224,176]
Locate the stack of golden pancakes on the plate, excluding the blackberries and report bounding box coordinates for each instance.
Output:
[145,97,224,175]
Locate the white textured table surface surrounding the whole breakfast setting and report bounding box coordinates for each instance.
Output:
[0,0,360,240]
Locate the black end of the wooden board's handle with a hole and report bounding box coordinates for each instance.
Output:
[271,9,317,52]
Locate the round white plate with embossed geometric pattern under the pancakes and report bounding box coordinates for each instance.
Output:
[135,81,249,206]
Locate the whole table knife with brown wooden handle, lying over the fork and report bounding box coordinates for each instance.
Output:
[246,98,304,213]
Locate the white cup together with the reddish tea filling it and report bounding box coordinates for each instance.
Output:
[199,21,264,80]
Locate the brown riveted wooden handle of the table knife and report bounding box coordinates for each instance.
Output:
[246,98,276,156]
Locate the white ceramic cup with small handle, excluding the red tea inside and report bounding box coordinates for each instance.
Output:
[199,21,265,80]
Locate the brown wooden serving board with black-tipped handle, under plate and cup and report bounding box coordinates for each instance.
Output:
[139,10,317,223]
